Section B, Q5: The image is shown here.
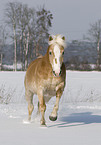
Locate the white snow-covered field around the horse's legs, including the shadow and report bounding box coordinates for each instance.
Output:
[0,71,101,145]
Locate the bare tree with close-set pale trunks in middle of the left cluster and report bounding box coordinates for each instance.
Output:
[17,4,36,70]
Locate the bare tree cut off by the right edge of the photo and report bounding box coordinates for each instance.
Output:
[87,20,101,69]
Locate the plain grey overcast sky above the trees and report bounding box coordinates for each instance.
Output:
[0,0,101,41]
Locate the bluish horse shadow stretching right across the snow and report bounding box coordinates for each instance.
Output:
[48,112,101,128]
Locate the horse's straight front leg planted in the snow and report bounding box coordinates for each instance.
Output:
[37,91,46,125]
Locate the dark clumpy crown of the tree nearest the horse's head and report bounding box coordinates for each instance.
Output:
[35,6,53,55]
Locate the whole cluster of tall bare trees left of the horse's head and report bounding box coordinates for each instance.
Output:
[0,2,53,71]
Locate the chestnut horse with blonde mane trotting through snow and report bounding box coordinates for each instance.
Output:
[25,35,66,125]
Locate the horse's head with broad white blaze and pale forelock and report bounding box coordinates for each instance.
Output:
[48,35,65,77]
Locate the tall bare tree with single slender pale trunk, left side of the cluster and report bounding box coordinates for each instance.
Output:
[5,2,19,71]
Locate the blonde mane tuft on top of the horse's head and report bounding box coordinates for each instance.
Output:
[48,35,66,47]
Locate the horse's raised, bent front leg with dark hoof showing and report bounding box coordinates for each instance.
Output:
[49,88,63,121]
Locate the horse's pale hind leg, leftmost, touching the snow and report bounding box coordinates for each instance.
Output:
[25,91,34,121]
